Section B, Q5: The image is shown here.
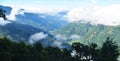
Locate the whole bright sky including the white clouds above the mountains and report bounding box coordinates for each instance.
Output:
[0,0,120,26]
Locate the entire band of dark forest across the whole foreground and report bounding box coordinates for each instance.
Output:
[0,37,119,61]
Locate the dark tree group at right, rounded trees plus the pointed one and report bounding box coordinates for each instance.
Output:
[72,37,120,61]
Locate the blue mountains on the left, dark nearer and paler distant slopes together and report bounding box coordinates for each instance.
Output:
[0,6,70,48]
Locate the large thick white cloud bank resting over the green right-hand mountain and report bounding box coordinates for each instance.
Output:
[65,5,120,26]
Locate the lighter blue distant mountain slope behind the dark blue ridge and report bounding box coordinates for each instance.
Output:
[16,12,67,31]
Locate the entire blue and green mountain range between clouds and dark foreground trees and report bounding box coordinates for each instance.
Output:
[0,6,120,47]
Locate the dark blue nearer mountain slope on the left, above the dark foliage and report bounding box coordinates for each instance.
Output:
[0,22,52,41]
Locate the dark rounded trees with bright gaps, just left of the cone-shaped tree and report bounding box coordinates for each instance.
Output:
[72,43,98,61]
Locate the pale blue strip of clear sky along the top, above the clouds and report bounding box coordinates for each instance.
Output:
[0,0,120,8]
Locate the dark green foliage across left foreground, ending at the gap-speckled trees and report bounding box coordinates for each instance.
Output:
[0,37,71,61]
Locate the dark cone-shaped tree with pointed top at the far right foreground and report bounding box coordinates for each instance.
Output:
[99,37,120,61]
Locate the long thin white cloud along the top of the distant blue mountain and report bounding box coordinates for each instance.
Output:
[7,6,68,21]
